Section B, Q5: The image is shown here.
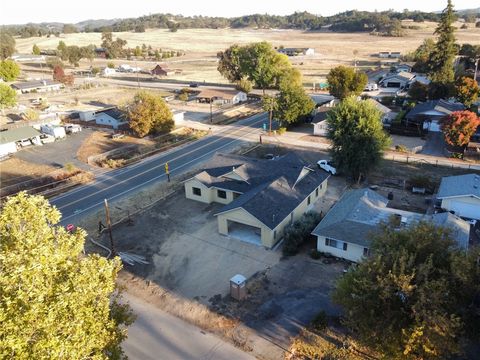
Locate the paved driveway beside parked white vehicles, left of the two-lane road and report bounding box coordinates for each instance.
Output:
[14,128,93,170]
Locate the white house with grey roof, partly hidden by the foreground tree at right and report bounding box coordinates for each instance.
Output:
[312,188,470,262]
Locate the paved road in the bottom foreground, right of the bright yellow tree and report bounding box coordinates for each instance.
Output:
[122,293,254,360]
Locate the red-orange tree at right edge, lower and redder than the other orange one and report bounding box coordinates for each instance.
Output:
[441,110,480,146]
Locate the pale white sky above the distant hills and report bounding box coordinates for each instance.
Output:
[0,0,479,25]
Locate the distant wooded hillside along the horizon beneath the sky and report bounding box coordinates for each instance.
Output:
[0,8,480,37]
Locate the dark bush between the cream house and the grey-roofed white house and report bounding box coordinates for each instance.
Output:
[282,211,322,256]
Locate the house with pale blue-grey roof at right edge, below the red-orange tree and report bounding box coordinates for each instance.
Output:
[437,174,480,220]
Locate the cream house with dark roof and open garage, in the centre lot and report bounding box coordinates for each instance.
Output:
[185,153,329,248]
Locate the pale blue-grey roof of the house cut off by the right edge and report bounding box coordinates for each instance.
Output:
[437,174,480,199]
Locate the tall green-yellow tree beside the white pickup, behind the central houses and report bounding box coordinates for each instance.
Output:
[327,97,389,182]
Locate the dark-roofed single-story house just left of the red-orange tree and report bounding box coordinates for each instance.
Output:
[405,99,465,132]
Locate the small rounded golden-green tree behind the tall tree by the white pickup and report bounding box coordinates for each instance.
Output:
[327,65,368,99]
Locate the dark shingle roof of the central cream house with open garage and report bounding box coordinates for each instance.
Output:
[195,153,329,229]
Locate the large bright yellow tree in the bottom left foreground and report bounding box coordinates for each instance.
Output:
[0,192,133,359]
